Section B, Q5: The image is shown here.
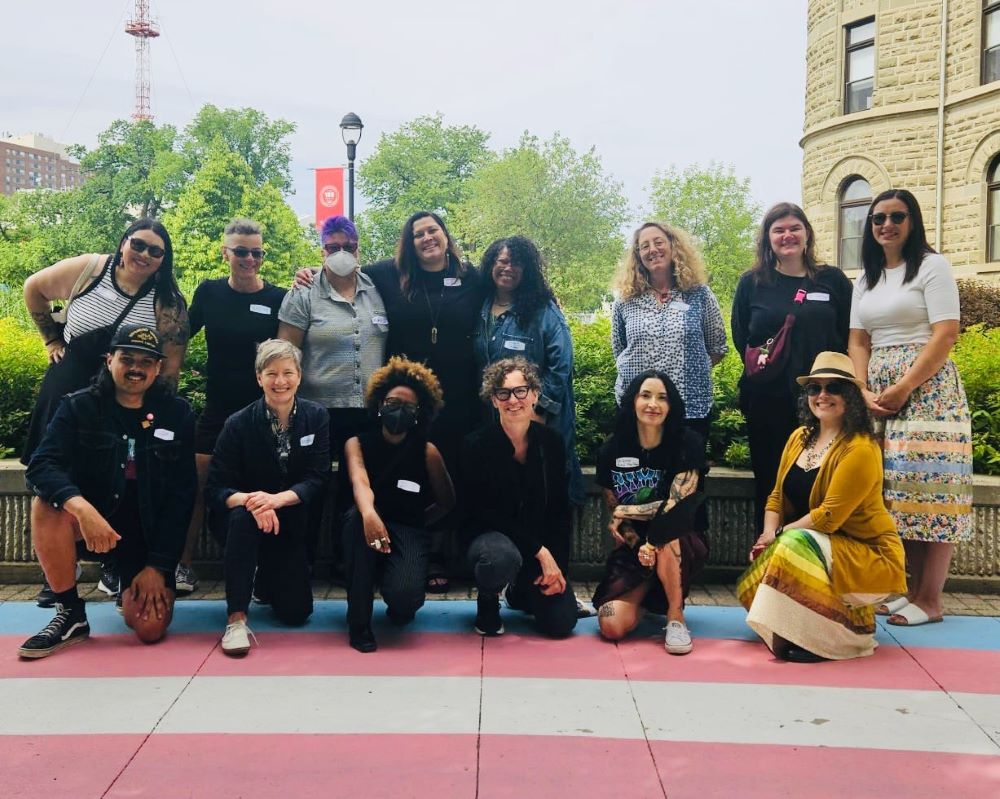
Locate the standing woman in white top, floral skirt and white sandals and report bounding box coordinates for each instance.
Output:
[849,189,973,625]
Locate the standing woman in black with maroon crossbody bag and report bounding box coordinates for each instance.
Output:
[732,203,852,530]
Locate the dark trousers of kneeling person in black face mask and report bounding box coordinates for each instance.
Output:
[342,508,430,627]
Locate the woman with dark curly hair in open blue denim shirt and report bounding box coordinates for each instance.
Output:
[474,236,584,505]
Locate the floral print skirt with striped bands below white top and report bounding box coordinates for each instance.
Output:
[868,344,973,543]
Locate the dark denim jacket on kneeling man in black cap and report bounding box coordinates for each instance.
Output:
[26,388,198,572]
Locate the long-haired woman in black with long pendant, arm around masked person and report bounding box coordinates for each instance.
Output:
[365,211,483,593]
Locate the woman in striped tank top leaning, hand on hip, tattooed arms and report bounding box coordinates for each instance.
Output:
[21,219,188,607]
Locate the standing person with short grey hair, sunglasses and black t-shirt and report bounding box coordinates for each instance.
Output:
[176,219,285,593]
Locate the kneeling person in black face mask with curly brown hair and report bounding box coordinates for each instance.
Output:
[338,358,455,652]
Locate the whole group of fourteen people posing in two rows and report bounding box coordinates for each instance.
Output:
[13,190,971,660]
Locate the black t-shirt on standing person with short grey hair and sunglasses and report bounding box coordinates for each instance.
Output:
[190,277,285,414]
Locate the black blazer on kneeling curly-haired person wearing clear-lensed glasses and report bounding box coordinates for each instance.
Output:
[458,422,572,569]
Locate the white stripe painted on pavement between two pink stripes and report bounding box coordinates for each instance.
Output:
[0,676,1000,755]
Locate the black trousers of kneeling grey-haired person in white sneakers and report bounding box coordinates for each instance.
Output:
[226,505,313,626]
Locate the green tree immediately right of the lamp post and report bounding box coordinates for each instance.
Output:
[358,114,495,261]
